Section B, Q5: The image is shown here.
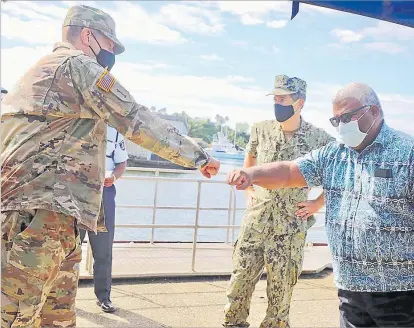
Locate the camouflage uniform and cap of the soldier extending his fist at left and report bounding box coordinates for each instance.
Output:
[1,6,209,328]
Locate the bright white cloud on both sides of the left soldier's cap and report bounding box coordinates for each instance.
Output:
[1,1,187,45]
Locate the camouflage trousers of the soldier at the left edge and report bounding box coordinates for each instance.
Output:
[1,210,82,328]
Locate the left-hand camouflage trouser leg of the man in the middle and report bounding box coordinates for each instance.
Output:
[224,226,264,326]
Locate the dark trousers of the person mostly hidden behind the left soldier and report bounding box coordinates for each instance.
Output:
[80,185,116,302]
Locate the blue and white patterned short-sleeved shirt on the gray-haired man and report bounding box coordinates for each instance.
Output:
[297,123,414,292]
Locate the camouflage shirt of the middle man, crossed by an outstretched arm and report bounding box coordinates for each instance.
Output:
[246,119,335,233]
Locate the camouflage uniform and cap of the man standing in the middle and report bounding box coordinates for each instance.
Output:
[224,76,334,328]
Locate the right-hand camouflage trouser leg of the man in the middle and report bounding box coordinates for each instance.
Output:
[260,232,306,328]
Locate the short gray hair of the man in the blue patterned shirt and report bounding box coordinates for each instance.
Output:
[332,82,382,113]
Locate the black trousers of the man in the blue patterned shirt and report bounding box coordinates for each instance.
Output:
[338,289,414,328]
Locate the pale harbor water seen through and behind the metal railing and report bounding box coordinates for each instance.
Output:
[115,160,326,242]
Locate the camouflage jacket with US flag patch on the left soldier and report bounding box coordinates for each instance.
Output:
[0,43,210,231]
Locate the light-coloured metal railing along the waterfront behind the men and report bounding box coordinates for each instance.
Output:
[86,167,323,274]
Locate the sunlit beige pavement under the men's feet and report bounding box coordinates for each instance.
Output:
[76,269,339,328]
